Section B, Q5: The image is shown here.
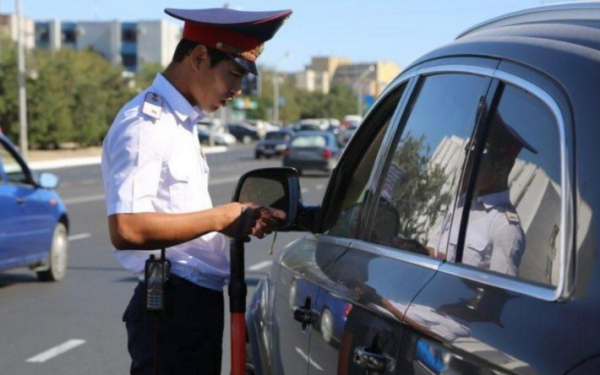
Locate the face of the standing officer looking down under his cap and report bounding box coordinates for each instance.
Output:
[190,54,246,112]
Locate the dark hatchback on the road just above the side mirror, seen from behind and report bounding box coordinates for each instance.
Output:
[283,131,340,175]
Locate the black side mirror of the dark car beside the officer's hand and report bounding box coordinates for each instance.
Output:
[233,168,302,231]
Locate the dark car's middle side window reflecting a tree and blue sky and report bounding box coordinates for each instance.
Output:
[367,74,489,256]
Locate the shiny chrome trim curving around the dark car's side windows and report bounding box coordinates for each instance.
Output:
[353,65,572,301]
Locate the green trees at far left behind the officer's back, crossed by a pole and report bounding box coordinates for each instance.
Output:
[0,41,134,149]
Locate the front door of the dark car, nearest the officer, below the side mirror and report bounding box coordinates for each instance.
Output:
[271,81,410,374]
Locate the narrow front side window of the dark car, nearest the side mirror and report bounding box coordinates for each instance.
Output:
[326,86,405,238]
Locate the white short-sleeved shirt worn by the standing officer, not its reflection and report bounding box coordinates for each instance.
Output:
[102,74,229,290]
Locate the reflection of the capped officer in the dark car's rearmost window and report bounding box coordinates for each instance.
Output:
[427,113,537,276]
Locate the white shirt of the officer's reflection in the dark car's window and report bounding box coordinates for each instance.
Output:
[427,190,525,276]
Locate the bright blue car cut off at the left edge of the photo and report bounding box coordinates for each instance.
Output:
[0,133,69,281]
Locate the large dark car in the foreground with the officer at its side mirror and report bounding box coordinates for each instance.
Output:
[238,3,600,375]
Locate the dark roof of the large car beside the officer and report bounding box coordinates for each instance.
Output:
[400,3,600,137]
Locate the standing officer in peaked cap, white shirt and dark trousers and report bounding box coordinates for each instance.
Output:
[102,9,291,375]
